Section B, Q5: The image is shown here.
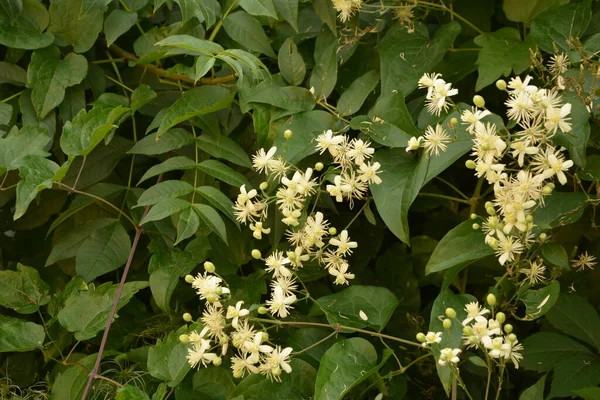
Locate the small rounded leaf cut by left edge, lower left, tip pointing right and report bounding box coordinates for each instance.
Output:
[0,315,46,353]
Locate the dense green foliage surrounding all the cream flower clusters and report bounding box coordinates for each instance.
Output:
[0,0,600,400]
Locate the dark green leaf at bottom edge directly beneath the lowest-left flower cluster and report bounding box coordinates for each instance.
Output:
[228,357,317,400]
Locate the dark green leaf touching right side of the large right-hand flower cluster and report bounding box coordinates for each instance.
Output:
[534,192,587,230]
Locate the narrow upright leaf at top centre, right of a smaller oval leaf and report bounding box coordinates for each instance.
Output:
[310,28,338,99]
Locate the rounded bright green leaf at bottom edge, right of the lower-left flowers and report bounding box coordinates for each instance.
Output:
[314,338,378,400]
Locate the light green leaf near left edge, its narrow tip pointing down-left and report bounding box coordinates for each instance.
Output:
[13,155,59,221]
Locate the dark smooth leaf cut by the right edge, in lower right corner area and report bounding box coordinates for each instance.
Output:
[546,293,600,349]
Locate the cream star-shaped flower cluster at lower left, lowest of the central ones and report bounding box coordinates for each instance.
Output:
[179,262,292,380]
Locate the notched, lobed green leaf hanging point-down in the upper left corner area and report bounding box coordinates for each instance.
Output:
[27,46,87,118]
